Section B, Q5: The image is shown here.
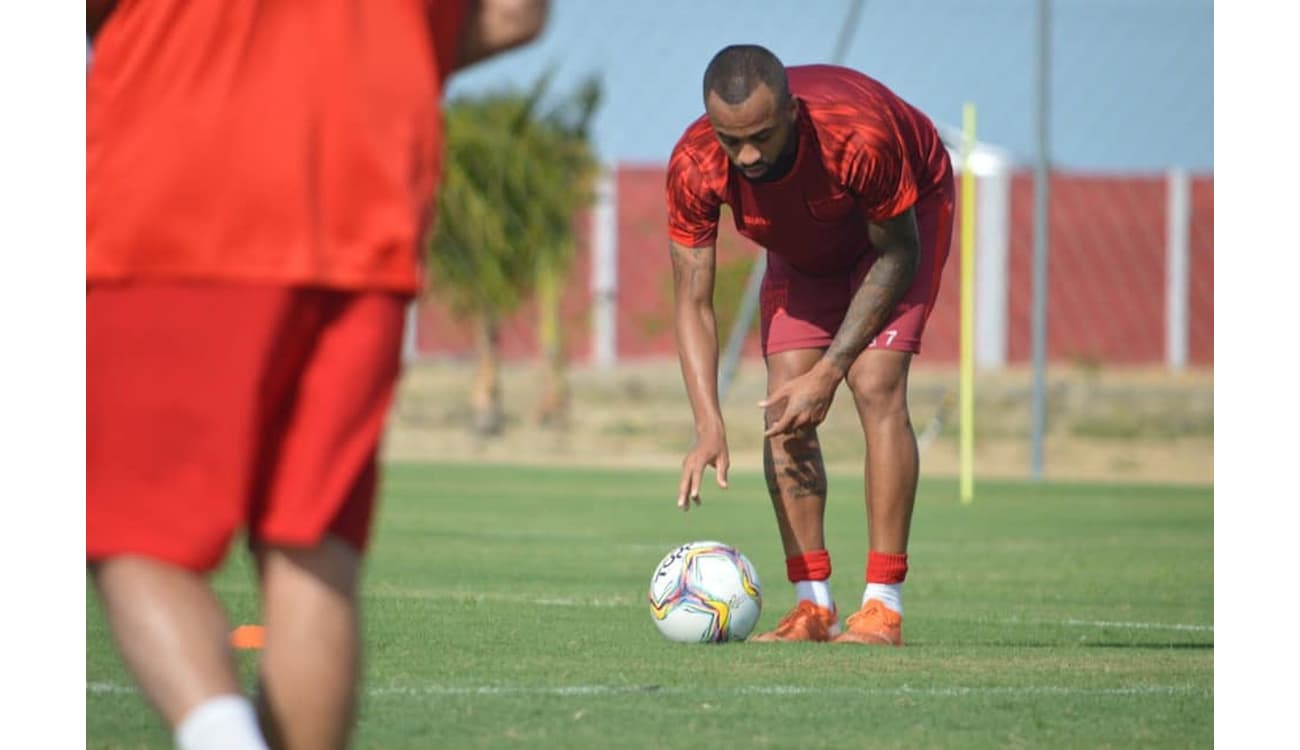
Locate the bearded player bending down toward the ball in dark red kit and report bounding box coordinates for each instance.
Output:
[667,44,954,646]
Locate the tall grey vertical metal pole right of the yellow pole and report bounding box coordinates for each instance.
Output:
[1030,0,1050,481]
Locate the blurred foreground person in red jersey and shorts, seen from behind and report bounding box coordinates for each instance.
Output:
[86,0,547,750]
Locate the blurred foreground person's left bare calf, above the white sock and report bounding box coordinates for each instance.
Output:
[91,556,239,729]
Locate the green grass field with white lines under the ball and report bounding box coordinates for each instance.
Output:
[86,465,1214,749]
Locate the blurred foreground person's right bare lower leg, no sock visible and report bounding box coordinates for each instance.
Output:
[257,536,361,750]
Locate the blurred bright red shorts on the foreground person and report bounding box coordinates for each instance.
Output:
[86,282,407,572]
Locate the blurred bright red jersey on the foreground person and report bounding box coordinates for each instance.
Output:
[86,0,467,291]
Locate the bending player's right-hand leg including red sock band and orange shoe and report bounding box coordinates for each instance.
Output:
[839,350,920,645]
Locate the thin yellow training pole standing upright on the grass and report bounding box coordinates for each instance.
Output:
[961,101,975,504]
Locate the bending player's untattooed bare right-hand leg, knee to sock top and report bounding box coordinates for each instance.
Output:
[848,350,920,554]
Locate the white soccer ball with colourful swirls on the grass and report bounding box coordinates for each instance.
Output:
[649,541,763,643]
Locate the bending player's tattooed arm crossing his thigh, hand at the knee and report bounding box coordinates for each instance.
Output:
[759,208,920,437]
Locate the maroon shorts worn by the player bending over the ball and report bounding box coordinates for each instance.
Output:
[759,181,956,356]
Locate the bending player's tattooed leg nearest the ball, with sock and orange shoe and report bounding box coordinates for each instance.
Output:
[753,350,839,642]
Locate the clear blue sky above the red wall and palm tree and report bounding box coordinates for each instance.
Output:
[449,0,1214,172]
